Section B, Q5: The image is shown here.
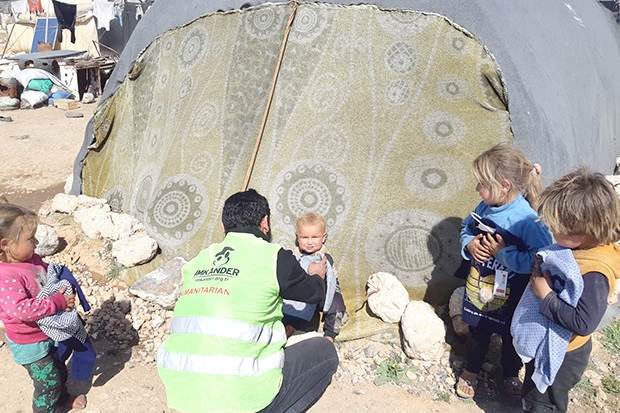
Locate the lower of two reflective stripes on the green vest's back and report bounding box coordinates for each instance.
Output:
[157,346,284,376]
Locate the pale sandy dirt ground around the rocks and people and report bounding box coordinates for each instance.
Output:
[0,104,610,413]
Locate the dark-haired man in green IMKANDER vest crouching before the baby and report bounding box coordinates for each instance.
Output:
[157,189,338,413]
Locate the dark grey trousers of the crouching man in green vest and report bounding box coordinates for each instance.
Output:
[260,337,339,413]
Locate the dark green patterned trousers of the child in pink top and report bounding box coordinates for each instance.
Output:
[23,347,68,413]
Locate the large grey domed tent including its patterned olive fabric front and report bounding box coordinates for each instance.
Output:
[73,0,620,338]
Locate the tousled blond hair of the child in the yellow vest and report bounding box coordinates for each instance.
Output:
[538,167,620,244]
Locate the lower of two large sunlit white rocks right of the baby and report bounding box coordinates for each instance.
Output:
[400,301,446,361]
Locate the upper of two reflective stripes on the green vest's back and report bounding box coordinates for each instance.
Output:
[170,316,286,344]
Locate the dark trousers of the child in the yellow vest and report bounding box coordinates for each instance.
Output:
[522,338,592,413]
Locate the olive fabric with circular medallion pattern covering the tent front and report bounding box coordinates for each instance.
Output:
[83,3,511,334]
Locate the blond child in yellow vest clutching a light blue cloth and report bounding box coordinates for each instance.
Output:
[511,168,620,413]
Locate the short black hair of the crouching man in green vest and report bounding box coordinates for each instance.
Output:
[222,189,271,232]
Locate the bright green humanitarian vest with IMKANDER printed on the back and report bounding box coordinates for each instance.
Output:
[157,232,286,413]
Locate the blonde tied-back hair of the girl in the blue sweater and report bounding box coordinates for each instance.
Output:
[473,143,542,209]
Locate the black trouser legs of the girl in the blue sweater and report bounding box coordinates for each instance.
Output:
[465,326,523,378]
